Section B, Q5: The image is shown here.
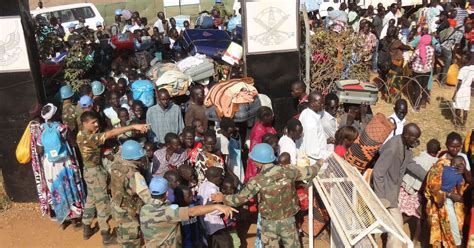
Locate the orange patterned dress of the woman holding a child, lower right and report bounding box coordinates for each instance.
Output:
[424,158,468,248]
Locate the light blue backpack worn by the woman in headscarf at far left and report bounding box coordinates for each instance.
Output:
[41,122,68,162]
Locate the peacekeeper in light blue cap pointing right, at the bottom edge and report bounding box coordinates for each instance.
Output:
[140,176,238,248]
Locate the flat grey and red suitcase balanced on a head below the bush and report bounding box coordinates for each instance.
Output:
[336,80,379,105]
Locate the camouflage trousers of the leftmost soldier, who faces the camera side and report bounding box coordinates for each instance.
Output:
[82,166,110,231]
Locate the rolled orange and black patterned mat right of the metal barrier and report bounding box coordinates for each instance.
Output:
[344,113,395,173]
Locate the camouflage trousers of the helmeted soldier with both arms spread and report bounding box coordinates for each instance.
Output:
[262,217,301,248]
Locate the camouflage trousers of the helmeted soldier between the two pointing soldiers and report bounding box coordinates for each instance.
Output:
[112,203,140,248]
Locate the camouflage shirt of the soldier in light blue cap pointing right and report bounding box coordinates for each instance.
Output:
[140,199,189,247]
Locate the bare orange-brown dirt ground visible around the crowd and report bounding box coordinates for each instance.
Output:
[0,80,474,248]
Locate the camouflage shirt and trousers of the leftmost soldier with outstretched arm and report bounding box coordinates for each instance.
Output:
[77,130,110,231]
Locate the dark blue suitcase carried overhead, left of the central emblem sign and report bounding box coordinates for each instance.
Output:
[183,29,231,59]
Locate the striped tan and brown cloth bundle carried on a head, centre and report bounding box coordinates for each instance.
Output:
[204,77,260,120]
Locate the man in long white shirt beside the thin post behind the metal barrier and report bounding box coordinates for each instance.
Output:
[299,92,331,164]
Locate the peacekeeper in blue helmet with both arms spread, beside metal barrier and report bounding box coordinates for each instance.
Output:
[211,143,319,248]
